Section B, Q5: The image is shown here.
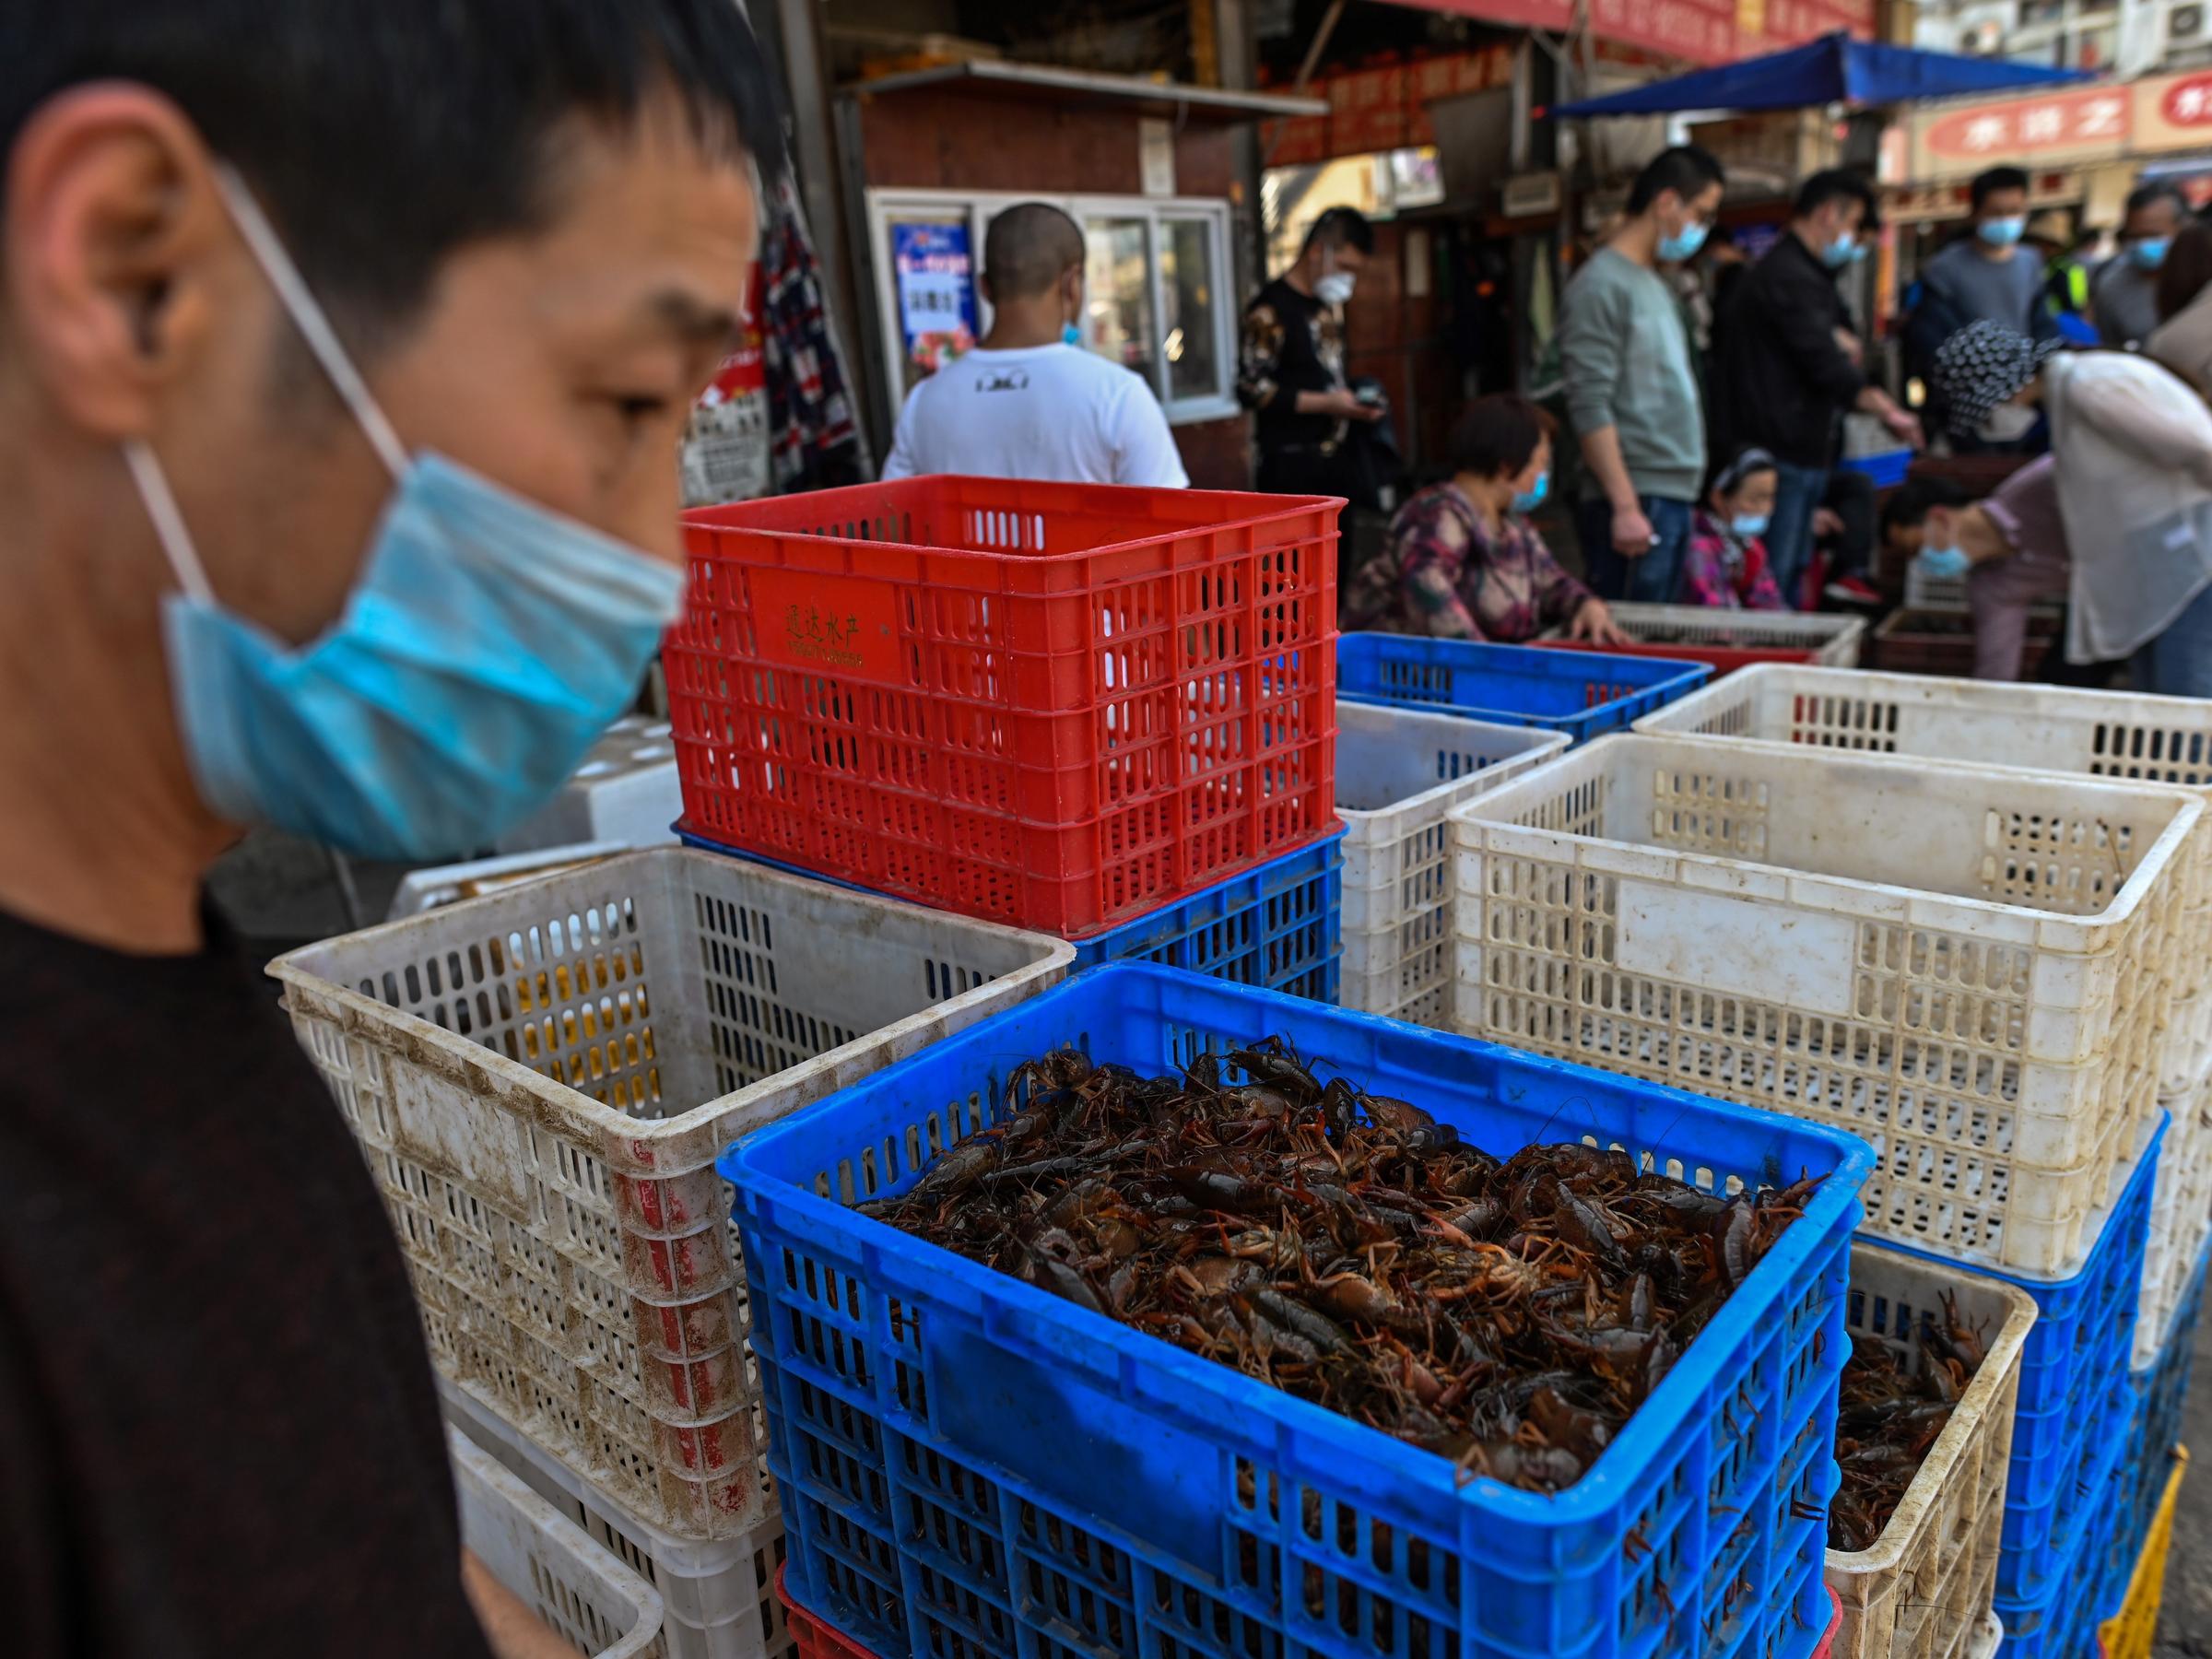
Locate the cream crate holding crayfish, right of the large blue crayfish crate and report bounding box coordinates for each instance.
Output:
[1827,1243,2035,1659]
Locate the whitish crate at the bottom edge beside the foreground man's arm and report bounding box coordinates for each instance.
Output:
[447,1429,662,1659]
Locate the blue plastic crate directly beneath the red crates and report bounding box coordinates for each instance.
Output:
[677,830,1345,1002]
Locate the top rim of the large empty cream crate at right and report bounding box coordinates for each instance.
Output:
[1451,730,2206,942]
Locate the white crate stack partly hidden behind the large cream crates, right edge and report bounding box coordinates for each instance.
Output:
[1637,668,2212,1367]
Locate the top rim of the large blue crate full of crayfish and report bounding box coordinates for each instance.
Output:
[717,962,1874,1528]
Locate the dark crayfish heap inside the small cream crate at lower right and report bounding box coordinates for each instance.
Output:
[1827,1292,1982,1553]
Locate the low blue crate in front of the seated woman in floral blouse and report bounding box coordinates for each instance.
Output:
[1336,632,1712,743]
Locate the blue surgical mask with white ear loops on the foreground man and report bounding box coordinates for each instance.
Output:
[124,168,684,861]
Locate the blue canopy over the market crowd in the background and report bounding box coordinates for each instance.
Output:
[1550,31,2095,115]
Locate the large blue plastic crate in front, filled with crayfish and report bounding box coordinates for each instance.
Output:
[721,964,1871,1659]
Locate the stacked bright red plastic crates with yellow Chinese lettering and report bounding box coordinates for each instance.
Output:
[664,477,1340,938]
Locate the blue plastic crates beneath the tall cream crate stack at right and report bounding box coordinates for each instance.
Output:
[1884,1115,2166,1632]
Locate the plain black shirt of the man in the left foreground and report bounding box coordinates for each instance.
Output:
[0,916,487,1659]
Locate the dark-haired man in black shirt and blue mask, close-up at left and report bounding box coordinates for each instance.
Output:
[0,0,779,1659]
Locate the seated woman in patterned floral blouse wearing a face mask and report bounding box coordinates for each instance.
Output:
[1343,394,1626,646]
